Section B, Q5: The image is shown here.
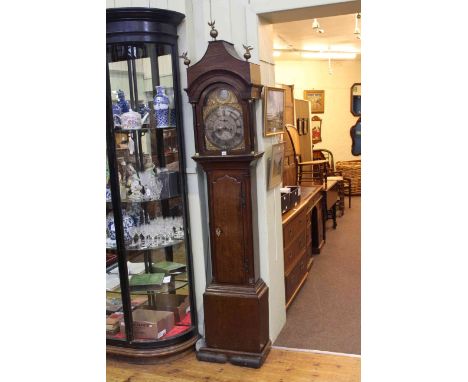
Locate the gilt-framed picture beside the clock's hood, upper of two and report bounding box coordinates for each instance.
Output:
[263,86,285,137]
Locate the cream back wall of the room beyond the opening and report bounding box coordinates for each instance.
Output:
[275,60,361,163]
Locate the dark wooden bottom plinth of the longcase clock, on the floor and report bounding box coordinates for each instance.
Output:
[197,340,271,369]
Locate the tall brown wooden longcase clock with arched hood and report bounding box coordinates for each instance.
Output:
[187,41,271,367]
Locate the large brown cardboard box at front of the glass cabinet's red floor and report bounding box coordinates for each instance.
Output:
[120,309,174,340]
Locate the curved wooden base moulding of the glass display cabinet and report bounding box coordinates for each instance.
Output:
[106,335,199,364]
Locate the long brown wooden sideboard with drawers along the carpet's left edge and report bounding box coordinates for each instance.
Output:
[283,186,325,308]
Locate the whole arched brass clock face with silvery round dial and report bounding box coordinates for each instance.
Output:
[203,88,245,151]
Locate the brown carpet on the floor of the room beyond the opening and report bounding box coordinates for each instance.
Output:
[274,196,361,354]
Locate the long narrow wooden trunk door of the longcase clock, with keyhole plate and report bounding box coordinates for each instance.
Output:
[210,171,248,284]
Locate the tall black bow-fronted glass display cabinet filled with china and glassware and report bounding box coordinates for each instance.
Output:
[106,8,197,357]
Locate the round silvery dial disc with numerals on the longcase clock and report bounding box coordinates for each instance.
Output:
[205,105,244,150]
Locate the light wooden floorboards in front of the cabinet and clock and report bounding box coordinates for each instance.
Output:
[107,349,361,382]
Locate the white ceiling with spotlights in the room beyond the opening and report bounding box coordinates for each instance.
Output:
[273,13,361,60]
